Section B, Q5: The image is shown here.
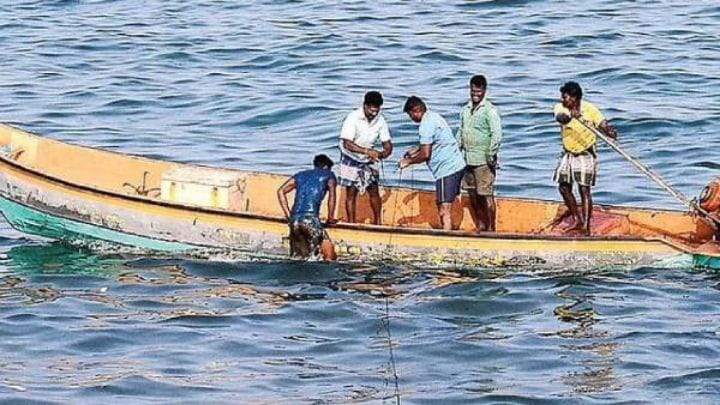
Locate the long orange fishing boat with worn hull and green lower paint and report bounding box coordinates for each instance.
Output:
[0,124,714,268]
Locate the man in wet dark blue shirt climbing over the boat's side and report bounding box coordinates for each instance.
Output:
[277,154,337,260]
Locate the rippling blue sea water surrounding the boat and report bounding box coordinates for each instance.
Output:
[0,0,720,404]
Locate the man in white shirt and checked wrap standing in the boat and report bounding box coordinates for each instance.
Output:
[339,91,393,225]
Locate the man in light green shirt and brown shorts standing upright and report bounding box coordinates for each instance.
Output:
[457,75,502,232]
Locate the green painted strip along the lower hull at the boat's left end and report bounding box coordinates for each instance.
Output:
[0,197,198,252]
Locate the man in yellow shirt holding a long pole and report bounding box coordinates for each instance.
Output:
[553,82,618,235]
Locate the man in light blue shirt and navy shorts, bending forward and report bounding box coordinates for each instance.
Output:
[399,96,465,230]
